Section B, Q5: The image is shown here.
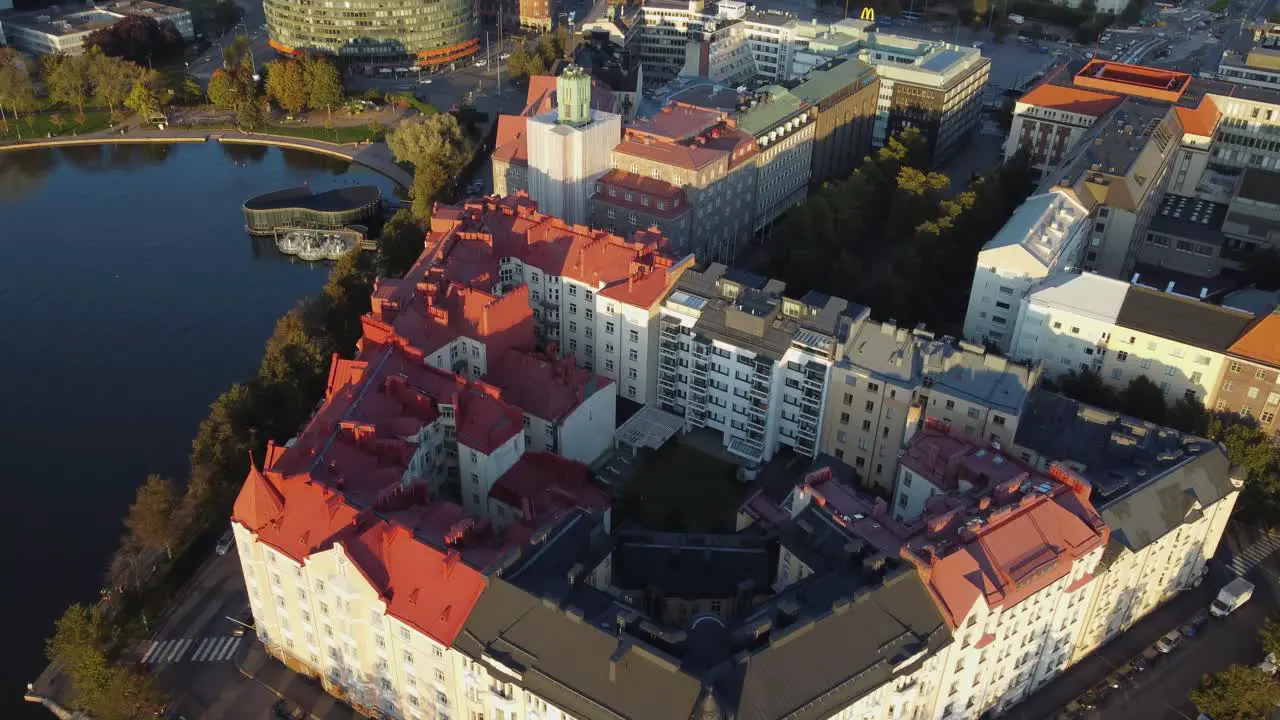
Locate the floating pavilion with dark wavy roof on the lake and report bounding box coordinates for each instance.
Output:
[244,184,381,234]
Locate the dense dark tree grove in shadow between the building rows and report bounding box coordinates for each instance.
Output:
[764,129,1032,329]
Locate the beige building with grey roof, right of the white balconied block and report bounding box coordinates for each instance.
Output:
[819,319,1039,495]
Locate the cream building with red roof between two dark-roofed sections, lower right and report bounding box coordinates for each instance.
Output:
[780,435,1108,720]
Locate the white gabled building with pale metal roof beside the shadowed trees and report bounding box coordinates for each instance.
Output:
[964,188,1094,352]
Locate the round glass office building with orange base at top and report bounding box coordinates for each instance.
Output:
[262,0,480,67]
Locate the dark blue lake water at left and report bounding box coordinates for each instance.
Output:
[0,142,394,717]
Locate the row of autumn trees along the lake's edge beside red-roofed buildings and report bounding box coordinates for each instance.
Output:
[46,248,384,720]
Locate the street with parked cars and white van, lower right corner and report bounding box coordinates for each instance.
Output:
[1100,592,1275,720]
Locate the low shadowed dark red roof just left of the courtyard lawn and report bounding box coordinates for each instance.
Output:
[489,452,611,521]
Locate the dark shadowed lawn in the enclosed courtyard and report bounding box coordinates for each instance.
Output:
[622,441,744,533]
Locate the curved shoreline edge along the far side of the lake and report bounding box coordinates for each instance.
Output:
[0,131,413,190]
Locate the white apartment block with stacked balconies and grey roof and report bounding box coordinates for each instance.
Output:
[657,263,867,462]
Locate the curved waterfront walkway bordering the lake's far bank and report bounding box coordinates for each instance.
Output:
[0,127,413,188]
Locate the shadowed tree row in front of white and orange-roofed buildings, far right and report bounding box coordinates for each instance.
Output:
[1052,370,1280,524]
